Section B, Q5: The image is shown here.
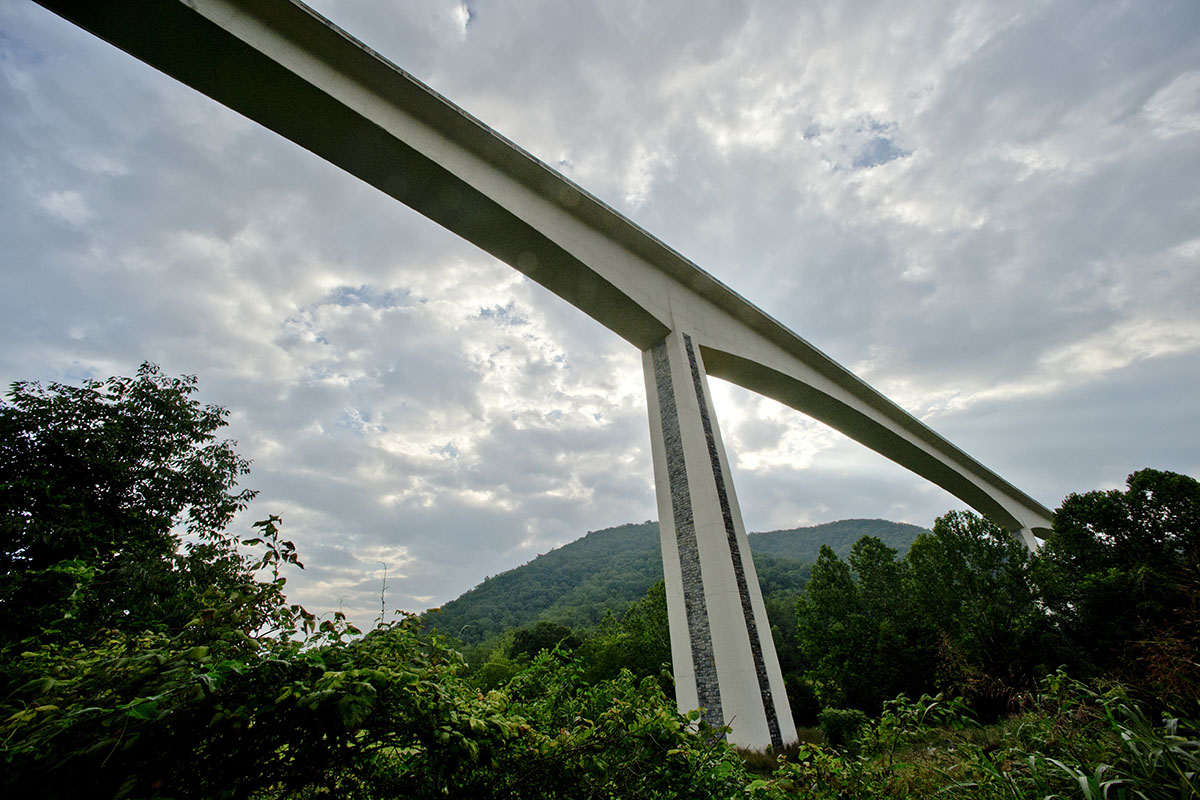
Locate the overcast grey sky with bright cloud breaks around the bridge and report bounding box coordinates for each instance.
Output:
[0,0,1200,622]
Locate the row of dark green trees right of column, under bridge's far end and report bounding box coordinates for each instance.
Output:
[797,469,1200,715]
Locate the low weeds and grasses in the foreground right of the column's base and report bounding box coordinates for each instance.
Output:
[746,672,1200,800]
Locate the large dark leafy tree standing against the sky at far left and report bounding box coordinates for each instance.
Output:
[0,363,254,642]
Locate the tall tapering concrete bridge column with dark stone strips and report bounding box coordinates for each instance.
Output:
[642,331,796,748]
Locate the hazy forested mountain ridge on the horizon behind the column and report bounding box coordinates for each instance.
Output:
[425,519,923,644]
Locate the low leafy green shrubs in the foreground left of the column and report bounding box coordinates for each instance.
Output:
[0,609,744,798]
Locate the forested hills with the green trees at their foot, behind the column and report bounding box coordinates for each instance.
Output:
[422,519,926,716]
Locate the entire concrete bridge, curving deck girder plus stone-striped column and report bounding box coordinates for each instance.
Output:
[37,0,1050,747]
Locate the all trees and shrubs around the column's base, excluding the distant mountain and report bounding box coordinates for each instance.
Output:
[0,365,1200,798]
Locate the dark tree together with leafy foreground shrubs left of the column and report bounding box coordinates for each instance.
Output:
[0,365,744,799]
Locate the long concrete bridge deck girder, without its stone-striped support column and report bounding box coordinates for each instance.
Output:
[38,0,1050,547]
